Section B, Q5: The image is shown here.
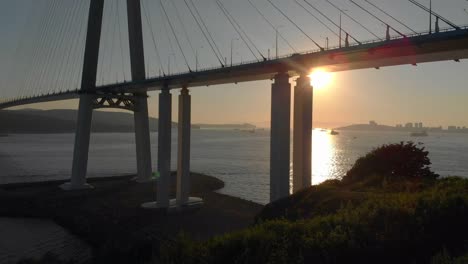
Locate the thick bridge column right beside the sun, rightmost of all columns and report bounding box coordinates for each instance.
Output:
[293,74,313,192]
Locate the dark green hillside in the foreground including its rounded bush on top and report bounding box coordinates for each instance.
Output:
[157,142,468,263]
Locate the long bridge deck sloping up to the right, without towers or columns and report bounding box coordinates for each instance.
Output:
[0,29,468,109]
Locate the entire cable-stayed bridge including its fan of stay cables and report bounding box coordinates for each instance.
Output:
[0,0,468,207]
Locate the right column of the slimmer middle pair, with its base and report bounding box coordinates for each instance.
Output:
[175,87,203,208]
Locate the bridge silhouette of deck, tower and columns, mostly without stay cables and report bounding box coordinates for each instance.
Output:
[0,0,468,208]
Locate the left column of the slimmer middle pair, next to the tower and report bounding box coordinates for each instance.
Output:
[156,89,172,208]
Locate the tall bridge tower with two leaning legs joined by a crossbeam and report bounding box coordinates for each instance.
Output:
[61,0,151,190]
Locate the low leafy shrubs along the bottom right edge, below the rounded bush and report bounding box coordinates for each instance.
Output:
[158,178,468,263]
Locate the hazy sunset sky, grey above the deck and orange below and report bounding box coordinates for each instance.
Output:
[0,0,468,126]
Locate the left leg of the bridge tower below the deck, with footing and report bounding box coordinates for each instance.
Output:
[60,94,93,190]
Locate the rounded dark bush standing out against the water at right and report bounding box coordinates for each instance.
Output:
[343,142,439,186]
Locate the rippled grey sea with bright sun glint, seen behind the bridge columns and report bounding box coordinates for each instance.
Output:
[0,130,468,204]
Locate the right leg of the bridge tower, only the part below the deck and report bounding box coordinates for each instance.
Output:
[134,93,152,182]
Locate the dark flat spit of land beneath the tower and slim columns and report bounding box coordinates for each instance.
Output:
[0,173,263,260]
